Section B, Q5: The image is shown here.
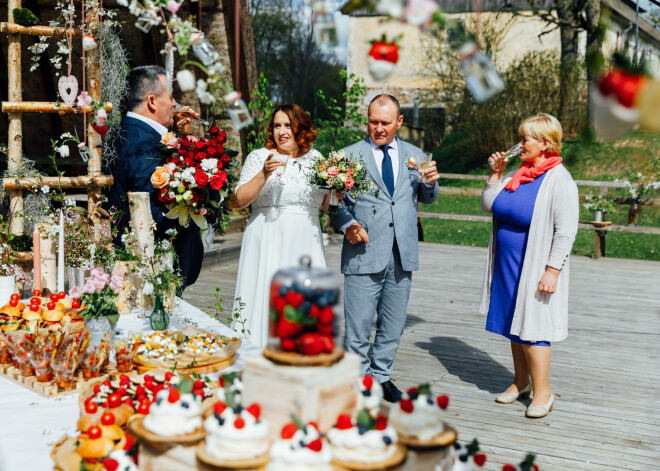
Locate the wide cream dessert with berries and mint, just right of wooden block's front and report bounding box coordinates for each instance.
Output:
[328,409,406,469]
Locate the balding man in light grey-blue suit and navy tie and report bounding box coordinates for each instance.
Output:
[331,95,439,402]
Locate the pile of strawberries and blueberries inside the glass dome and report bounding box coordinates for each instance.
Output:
[270,282,339,355]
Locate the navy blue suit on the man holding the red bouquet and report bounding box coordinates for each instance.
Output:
[108,116,204,286]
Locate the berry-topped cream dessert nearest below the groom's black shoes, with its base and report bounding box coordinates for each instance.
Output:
[390,383,456,446]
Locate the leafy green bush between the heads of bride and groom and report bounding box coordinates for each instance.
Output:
[315,70,367,155]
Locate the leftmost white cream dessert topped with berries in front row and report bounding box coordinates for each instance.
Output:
[143,387,202,437]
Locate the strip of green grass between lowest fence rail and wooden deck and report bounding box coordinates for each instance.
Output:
[422,219,660,261]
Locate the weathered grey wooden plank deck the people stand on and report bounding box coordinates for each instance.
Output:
[184,243,660,471]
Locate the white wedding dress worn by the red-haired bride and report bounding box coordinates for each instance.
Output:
[232,149,327,348]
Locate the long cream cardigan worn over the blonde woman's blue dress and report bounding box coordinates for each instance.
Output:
[480,164,580,342]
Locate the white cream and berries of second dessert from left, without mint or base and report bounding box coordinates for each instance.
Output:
[204,402,269,461]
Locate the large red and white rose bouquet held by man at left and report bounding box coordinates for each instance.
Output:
[151,126,238,229]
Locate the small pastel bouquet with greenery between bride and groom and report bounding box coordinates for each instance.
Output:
[309,151,371,196]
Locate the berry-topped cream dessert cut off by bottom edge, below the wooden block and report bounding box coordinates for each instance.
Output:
[266,416,334,471]
